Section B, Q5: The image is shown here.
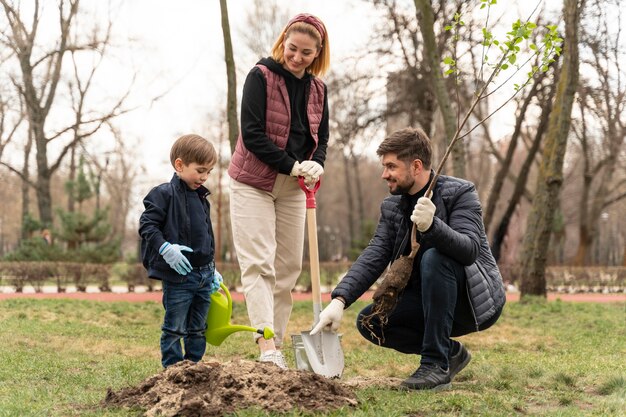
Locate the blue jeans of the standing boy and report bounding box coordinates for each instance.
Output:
[161,264,215,368]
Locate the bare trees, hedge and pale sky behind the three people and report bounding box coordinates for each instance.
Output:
[0,0,626,295]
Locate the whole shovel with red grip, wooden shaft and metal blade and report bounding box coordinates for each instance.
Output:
[298,177,343,378]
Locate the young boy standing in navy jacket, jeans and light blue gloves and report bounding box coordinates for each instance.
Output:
[139,135,222,368]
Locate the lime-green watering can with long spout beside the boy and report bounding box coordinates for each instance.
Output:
[205,283,274,346]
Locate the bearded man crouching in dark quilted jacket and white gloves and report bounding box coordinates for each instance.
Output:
[311,128,505,390]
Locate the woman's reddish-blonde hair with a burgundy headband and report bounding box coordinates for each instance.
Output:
[272,18,330,77]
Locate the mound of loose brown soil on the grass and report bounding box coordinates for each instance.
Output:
[103,360,357,416]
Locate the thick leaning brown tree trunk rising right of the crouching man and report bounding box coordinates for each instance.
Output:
[520,0,582,297]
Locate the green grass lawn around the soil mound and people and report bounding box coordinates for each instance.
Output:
[0,299,626,416]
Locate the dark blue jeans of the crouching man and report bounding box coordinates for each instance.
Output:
[357,248,499,369]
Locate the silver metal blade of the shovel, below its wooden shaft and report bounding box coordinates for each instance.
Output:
[301,330,344,378]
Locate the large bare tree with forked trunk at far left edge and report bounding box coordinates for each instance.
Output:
[0,0,130,225]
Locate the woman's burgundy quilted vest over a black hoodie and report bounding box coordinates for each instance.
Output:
[228,64,324,191]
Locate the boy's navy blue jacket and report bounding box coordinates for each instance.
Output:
[139,174,215,282]
